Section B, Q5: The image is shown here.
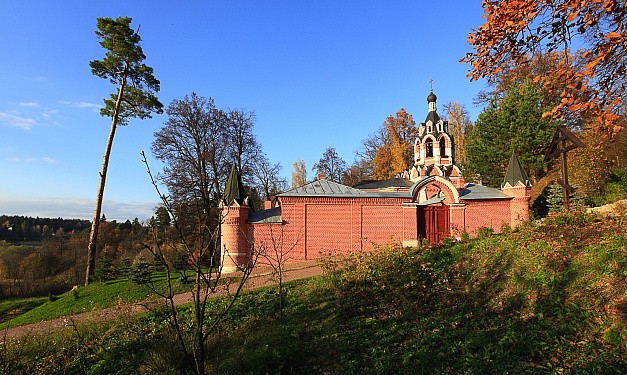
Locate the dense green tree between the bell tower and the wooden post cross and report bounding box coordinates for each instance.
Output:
[466,83,555,186]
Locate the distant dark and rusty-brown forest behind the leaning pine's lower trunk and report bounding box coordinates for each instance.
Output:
[0,215,150,300]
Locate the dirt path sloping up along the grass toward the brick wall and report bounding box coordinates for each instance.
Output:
[0,260,322,341]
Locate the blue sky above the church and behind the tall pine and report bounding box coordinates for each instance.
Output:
[0,0,485,220]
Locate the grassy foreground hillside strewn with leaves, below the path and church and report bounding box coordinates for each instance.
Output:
[0,213,627,374]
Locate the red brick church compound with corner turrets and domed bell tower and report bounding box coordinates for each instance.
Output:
[221,92,531,271]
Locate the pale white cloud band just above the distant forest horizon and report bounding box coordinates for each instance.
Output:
[0,197,157,222]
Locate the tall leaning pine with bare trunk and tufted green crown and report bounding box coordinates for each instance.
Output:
[85,17,163,284]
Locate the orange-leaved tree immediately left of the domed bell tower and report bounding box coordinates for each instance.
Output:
[372,108,418,180]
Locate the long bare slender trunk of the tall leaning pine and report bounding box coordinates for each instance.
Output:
[85,73,126,285]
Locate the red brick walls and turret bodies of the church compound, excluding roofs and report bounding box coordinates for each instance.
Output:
[222,181,529,270]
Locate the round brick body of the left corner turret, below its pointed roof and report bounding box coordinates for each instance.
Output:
[220,203,253,272]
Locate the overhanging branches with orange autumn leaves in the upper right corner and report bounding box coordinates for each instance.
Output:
[461,0,627,134]
